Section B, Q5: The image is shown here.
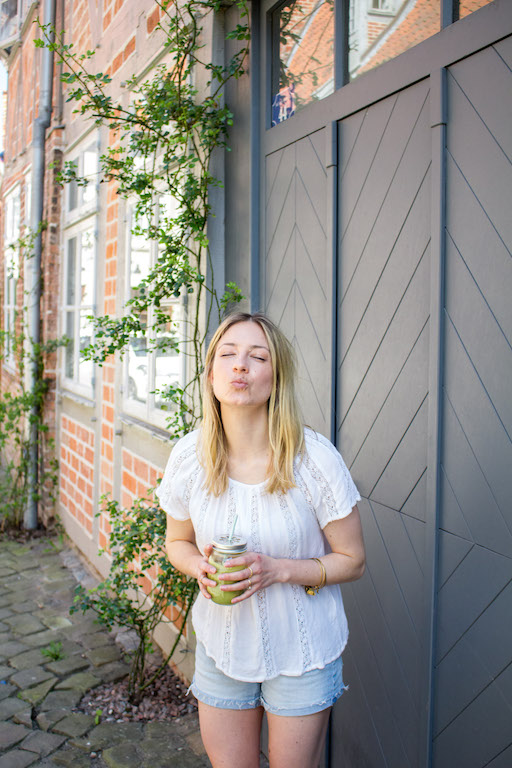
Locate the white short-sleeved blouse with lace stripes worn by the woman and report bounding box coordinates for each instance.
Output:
[157,429,361,682]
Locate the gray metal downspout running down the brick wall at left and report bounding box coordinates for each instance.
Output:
[24,0,56,530]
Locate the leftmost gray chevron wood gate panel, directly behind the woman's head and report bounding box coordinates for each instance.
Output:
[264,131,332,435]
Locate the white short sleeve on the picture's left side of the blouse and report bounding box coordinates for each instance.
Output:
[156,432,199,521]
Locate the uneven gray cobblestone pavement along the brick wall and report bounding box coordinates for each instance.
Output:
[0,539,210,768]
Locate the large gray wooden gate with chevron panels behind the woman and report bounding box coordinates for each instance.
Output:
[262,4,512,768]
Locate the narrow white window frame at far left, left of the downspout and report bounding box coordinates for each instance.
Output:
[3,184,21,372]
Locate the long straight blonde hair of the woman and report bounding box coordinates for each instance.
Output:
[199,312,304,496]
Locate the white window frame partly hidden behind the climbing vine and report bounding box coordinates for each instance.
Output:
[122,196,186,429]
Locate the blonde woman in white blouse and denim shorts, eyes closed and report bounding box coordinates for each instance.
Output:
[158,313,365,768]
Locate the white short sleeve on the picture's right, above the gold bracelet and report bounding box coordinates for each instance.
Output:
[304,432,361,528]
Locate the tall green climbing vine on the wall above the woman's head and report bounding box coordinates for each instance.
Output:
[36,0,250,437]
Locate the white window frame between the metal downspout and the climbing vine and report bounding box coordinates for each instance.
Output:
[61,216,98,399]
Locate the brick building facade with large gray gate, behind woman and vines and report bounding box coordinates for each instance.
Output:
[1,0,512,768]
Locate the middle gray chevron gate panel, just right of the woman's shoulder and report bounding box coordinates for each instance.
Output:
[334,82,431,768]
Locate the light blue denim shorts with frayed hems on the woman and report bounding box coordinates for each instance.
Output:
[190,643,345,717]
